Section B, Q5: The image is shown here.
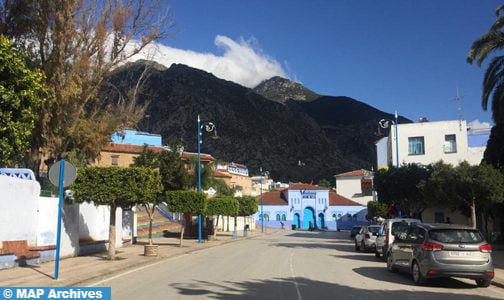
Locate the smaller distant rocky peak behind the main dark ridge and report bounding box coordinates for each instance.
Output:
[253,76,320,103]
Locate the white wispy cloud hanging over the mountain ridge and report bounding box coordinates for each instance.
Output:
[131,35,287,87]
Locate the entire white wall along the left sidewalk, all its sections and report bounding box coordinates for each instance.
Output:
[0,175,128,256]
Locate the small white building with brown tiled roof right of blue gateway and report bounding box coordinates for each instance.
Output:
[334,170,373,205]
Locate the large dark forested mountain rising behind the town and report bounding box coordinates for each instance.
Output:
[106,61,410,183]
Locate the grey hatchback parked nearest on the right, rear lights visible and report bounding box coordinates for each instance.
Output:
[387,224,494,287]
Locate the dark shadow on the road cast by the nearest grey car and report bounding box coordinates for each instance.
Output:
[353,266,477,289]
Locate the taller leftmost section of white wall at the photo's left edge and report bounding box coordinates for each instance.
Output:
[0,175,40,245]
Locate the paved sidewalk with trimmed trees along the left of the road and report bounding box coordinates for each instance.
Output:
[0,229,276,286]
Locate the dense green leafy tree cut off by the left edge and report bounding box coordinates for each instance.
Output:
[0,35,45,167]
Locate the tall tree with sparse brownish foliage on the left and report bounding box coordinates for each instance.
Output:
[0,0,172,173]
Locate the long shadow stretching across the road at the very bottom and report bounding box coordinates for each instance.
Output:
[171,274,491,300]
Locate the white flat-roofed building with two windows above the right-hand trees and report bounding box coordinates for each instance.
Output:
[376,120,490,169]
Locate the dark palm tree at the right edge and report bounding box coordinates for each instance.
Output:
[467,5,504,168]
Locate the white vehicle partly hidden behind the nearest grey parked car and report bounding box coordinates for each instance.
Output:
[375,218,422,257]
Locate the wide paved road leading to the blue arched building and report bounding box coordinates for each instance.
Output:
[88,231,504,300]
